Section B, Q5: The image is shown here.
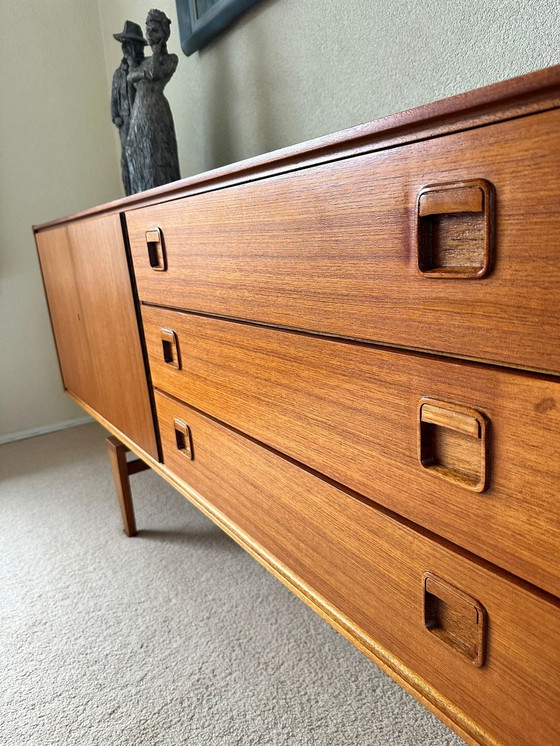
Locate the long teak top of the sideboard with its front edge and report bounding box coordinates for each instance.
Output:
[34,65,560,231]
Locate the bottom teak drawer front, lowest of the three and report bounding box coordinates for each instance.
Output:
[156,393,560,746]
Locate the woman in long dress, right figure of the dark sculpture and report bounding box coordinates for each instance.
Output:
[126,10,181,193]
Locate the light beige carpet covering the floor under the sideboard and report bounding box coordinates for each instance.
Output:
[0,424,463,746]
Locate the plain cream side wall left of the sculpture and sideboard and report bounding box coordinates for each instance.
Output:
[0,0,120,438]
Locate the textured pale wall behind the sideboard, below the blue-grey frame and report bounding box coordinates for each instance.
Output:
[99,0,560,176]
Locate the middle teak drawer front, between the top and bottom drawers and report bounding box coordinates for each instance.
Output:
[143,306,560,595]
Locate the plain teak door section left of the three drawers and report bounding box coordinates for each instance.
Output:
[37,215,157,457]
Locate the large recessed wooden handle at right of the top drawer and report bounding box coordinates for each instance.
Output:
[416,179,495,280]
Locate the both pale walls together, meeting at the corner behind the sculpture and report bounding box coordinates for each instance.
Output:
[0,0,560,436]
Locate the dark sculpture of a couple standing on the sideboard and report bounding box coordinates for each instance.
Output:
[111,10,181,195]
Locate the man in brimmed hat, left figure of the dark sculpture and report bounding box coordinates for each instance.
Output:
[111,21,147,195]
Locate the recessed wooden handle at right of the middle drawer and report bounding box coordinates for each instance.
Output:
[418,397,488,492]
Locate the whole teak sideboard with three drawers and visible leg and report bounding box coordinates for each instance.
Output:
[35,66,560,746]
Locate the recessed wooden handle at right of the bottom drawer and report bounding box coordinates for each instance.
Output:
[422,571,488,668]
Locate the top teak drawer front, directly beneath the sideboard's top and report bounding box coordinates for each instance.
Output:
[126,110,560,371]
